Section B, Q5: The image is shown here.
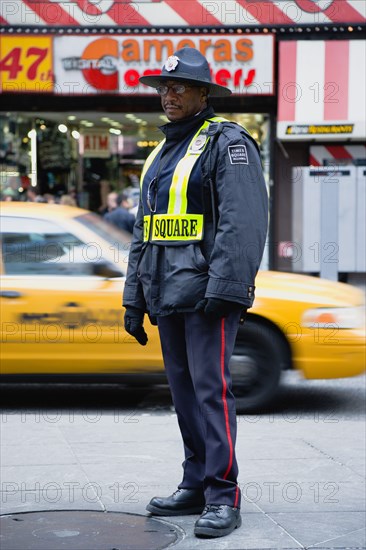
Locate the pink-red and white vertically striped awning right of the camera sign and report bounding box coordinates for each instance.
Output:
[277,40,366,140]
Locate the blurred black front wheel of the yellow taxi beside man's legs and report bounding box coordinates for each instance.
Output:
[230,316,284,414]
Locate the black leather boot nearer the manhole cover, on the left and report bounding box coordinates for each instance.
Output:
[146,489,205,516]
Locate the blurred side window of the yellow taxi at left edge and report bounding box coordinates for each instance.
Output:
[1,216,92,276]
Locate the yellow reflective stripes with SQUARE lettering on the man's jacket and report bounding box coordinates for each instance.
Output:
[140,117,226,241]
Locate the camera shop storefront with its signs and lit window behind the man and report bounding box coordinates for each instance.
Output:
[0,28,275,210]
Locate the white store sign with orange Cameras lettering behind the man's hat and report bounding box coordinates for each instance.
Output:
[54,35,274,95]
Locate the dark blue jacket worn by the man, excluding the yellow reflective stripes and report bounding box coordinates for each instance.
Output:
[123,107,268,316]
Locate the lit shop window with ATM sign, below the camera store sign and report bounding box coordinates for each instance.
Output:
[0,112,269,212]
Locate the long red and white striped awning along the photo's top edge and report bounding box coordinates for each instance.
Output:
[0,0,366,28]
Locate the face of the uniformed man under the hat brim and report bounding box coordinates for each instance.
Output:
[161,80,207,122]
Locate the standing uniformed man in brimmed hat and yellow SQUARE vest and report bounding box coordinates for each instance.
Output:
[123,48,268,537]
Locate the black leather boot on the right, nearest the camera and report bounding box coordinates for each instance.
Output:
[194,504,241,537]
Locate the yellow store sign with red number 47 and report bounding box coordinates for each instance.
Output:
[0,36,53,93]
